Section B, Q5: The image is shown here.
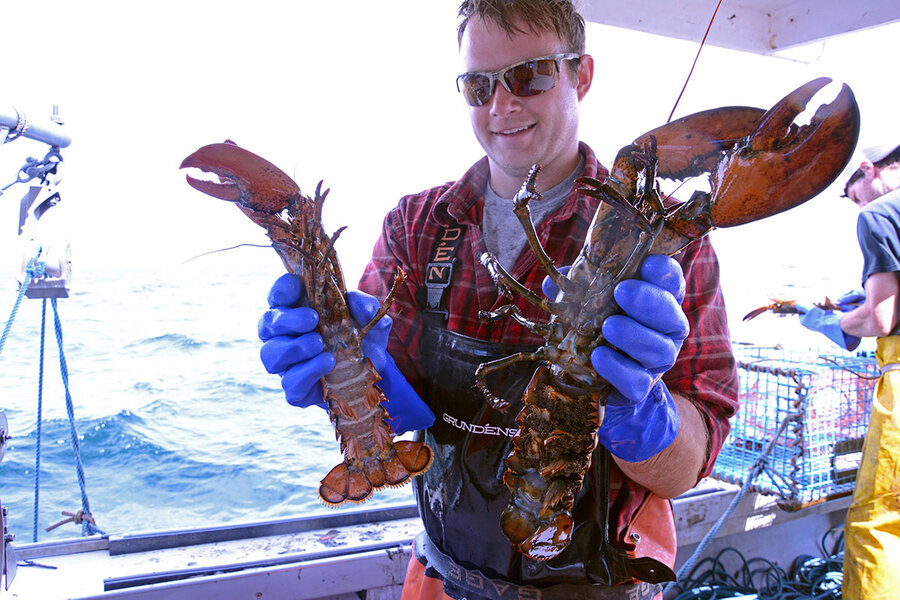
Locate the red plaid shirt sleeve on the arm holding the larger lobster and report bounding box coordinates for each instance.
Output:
[663,237,738,477]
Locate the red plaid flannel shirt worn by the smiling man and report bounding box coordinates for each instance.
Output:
[359,143,738,532]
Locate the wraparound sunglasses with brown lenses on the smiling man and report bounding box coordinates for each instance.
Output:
[456,52,581,106]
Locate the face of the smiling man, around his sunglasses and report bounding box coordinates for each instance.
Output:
[460,19,592,196]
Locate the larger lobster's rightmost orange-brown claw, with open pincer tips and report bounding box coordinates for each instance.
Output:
[710,77,859,227]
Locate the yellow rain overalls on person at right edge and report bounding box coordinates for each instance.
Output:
[842,335,900,600]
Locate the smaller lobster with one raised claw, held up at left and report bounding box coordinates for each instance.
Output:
[181,141,432,507]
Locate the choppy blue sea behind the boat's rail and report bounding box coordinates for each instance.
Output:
[0,230,872,543]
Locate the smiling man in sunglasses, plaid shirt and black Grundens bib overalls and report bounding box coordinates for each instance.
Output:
[259,0,737,600]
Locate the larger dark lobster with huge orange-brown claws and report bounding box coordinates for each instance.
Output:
[476,77,859,560]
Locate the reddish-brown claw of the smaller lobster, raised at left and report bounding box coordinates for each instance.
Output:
[181,140,300,213]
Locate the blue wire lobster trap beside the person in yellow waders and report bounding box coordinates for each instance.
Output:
[712,345,879,510]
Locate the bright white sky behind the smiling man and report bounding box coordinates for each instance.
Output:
[0,0,900,338]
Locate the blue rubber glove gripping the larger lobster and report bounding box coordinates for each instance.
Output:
[543,254,689,462]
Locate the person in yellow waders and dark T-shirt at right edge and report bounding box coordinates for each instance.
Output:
[800,146,900,600]
